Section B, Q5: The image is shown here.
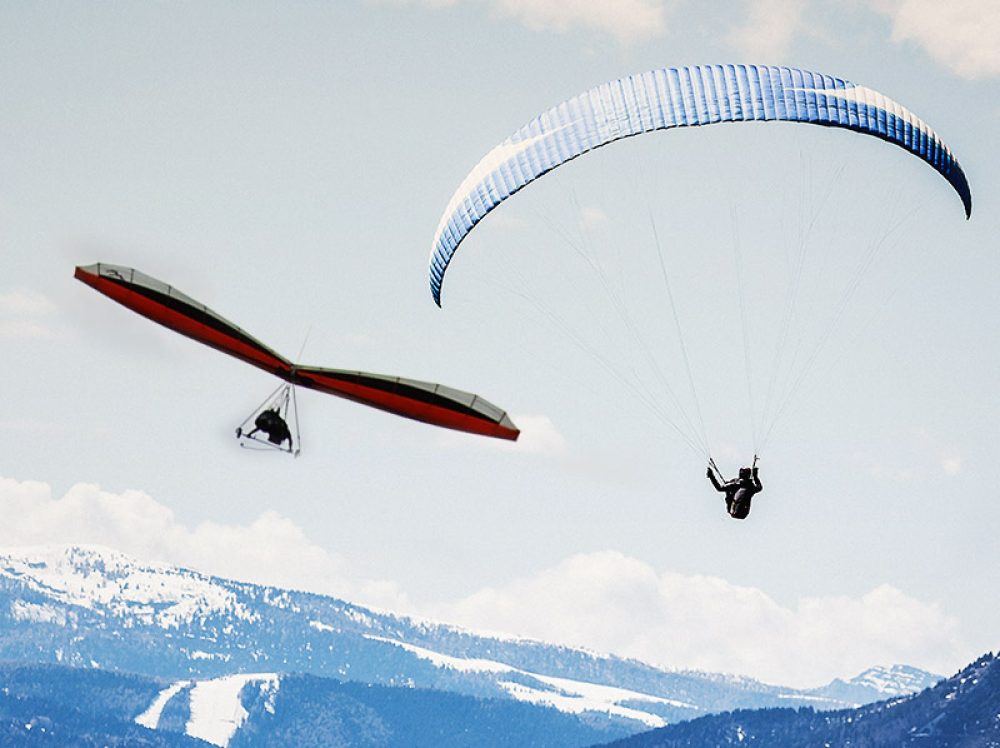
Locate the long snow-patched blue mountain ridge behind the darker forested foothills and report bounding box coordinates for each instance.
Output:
[0,547,936,733]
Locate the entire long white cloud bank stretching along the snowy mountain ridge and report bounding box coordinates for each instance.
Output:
[0,478,966,686]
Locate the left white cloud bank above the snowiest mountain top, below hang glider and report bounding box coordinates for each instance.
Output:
[0,478,409,610]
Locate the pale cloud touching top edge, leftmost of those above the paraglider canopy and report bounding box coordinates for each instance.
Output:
[382,0,674,44]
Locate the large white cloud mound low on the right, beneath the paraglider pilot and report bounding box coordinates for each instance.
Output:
[434,551,960,686]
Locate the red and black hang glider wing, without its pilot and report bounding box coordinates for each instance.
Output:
[74,263,520,441]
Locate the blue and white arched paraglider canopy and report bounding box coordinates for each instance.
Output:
[429,60,972,306]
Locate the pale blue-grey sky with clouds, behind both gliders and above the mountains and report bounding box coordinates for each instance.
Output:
[0,0,1000,686]
